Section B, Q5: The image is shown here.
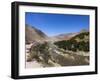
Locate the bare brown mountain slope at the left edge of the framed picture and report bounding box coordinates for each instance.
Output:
[25,24,48,44]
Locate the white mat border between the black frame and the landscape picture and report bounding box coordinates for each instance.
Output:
[19,6,95,76]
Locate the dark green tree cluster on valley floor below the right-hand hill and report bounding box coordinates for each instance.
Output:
[54,41,89,51]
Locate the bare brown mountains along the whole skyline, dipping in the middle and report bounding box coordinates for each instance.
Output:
[25,24,88,43]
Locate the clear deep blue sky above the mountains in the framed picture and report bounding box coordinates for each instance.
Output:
[25,12,89,36]
